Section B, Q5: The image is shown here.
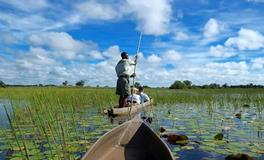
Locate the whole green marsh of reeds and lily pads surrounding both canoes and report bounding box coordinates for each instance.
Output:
[0,87,264,159]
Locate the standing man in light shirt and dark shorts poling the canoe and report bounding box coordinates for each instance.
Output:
[115,52,137,108]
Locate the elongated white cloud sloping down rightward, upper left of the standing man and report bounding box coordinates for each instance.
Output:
[29,32,103,60]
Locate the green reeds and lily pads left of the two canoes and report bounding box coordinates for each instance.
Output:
[0,88,116,159]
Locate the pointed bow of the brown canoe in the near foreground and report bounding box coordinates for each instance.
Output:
[82,116,173,160]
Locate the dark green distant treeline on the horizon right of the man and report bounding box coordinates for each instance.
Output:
[169,80,264,89]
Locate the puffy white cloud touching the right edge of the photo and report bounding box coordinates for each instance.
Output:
[225,28,264,50]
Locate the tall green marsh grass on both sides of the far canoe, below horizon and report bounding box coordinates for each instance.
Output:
[0,87,264,159]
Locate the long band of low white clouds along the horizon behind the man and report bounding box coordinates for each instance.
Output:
[0,46,264,86]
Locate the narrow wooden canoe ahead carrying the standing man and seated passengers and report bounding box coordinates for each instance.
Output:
[104,99,153,116]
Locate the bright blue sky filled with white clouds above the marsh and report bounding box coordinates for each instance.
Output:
[0,0,264,87]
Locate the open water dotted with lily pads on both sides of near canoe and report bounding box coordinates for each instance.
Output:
[0,101,264,160]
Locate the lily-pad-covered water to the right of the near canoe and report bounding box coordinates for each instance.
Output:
[152,104,264,160]
